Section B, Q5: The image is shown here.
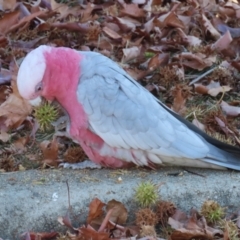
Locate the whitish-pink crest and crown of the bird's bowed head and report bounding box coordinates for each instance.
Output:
[17,45,51,99]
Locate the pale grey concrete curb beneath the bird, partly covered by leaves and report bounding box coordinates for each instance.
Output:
[0,168,240,240]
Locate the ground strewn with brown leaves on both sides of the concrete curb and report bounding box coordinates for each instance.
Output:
[0,0,240,240]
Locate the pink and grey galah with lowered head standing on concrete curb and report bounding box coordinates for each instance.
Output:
[17,45,240,170]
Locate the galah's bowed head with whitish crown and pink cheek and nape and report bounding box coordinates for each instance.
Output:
[17,45,81,104]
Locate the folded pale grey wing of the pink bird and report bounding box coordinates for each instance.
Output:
[77,50,209,165]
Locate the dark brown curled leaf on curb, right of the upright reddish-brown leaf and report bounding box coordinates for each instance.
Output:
[106,199,128,225]
